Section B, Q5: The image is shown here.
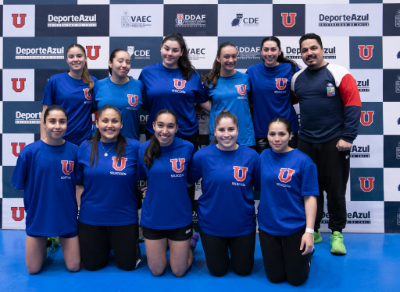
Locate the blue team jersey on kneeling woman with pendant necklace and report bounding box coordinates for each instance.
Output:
[76,138,140,226]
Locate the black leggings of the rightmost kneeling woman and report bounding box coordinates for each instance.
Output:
[259,229,311,286]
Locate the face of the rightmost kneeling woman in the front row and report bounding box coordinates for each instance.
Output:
[268,122,292,153]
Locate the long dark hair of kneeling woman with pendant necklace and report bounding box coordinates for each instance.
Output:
[88,104,126,168]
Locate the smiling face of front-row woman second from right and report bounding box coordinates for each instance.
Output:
[214,118,239,151]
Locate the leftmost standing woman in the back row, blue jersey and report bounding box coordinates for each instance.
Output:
[40,44,97,145]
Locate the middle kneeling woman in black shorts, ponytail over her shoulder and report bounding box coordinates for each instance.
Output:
[137,109,196,277]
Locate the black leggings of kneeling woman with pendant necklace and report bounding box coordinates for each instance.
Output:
[78,221,140,271]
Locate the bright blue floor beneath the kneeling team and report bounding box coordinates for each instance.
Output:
[0,230,400,292]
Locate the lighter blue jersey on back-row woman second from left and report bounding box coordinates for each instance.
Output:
[93,77,144,140]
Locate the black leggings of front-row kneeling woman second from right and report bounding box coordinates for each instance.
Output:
[200,230,256,277]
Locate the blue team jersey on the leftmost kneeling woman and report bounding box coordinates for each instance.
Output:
[11,140,78,237]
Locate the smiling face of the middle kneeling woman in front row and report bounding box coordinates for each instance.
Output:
[153,114,178,147]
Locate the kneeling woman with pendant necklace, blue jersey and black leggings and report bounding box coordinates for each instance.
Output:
[76,105,140,271]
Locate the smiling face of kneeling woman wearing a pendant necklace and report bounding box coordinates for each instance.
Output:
[96,109,122,143]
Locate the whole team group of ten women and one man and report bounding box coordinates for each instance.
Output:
[12,33,361,286]
